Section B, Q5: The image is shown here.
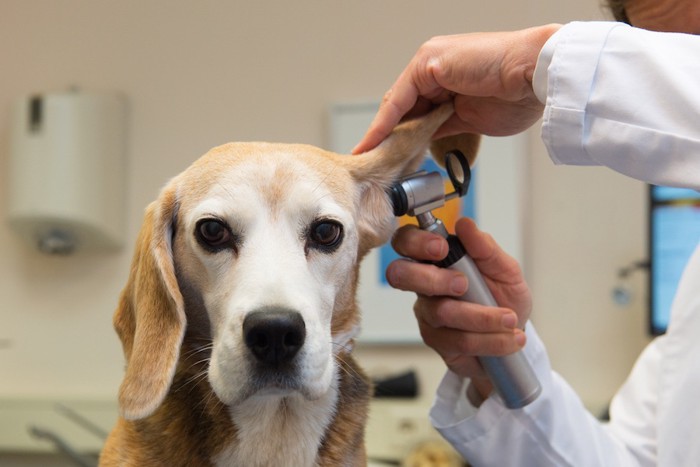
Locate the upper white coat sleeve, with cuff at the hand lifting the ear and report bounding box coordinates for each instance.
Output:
[533,22,700,189]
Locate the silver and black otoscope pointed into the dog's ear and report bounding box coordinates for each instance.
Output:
[390,150,542,409]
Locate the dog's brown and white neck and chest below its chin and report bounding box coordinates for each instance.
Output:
[102,346,371,467]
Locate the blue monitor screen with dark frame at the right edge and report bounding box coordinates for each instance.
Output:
[649,186,700,335]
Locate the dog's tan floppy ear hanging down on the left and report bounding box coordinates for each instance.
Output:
[114,189,185,420]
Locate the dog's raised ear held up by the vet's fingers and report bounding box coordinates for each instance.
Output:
[349,103,479,254]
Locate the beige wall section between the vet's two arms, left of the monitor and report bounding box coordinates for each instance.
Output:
[526,141,649,410]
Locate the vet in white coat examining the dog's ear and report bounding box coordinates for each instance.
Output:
[356,0,700,467]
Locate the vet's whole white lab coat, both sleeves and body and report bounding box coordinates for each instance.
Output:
[431,22,700,467]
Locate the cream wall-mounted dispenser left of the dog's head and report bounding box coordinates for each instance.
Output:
[8,91,126,254]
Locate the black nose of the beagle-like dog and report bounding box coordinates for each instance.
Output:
[243,308,306,365]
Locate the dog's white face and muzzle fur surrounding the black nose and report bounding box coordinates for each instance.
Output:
[181,155,358,405]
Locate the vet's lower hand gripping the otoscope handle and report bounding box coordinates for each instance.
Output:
[387,218,532,398]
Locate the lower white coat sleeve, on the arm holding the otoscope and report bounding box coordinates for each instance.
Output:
[430,324,653,467]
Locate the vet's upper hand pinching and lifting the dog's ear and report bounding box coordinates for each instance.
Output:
[353,25,561,154]
